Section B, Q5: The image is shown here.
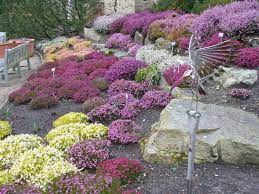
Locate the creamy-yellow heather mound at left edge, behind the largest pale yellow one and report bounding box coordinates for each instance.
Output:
[0,134,43,167]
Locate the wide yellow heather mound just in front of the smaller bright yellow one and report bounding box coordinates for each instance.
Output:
[46,123,108,151]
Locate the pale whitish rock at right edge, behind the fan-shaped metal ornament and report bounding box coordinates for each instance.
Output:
[214,67,258,88]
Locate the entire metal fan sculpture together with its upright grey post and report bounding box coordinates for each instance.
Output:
[187,34,239,194]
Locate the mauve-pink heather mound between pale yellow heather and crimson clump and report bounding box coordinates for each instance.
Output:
[68,140,110,169]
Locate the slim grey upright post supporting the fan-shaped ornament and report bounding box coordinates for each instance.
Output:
[187,110,201,194]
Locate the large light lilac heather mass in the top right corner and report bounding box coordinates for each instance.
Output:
[191,0,258,40]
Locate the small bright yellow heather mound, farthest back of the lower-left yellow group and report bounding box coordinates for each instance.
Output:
[53,112,88,127]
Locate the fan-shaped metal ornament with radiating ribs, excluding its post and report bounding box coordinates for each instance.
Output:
[189,34,239,95]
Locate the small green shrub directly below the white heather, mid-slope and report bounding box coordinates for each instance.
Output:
[135,66,161,85]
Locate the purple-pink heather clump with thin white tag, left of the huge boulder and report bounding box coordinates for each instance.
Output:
[88,93,139,121]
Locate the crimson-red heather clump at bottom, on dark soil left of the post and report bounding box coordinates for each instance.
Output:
[97,158,143,184]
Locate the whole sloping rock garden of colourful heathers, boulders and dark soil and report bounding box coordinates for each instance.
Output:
[0,0,259,194]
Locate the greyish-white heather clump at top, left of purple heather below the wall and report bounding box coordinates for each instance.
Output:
[93,13,124,33]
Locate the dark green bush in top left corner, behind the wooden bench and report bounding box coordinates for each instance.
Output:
[0,0,97,39]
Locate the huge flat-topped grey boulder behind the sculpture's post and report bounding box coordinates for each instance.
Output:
[141,99,259,165]
